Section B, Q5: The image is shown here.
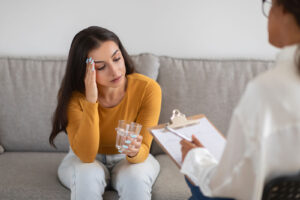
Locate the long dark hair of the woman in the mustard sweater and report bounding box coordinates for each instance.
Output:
[49,26,134,147]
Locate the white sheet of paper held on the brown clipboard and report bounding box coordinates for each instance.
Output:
[150,117,226,167]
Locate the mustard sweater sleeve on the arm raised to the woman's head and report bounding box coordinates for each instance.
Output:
[66,95,100,163]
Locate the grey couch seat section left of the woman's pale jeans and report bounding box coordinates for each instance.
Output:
[0,152,70,200]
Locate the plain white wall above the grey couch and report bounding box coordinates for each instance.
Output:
[0,0,277,59]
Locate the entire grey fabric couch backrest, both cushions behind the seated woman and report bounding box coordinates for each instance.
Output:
[0,54,272,154]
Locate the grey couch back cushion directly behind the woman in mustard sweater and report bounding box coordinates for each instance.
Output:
[0,54,159,151]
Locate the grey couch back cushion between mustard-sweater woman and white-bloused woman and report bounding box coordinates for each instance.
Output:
[152,57,273,155]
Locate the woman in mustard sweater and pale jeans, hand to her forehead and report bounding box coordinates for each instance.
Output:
[49,26,161,200]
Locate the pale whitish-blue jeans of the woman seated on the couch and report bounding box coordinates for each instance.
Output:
[58,147,160,200]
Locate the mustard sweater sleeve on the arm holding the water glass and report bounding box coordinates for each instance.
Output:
[127,81,162,163]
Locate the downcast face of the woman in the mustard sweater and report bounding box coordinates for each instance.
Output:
[88,41,126,88]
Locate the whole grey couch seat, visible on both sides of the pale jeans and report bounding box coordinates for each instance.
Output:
[0,152,190,200]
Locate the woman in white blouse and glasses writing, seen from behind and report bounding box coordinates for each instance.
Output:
[181,0,300,200]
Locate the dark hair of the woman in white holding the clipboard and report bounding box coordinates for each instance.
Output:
[276,0,300,74]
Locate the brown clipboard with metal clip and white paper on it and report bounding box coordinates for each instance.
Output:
[149,109,226,168]
